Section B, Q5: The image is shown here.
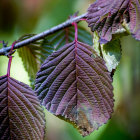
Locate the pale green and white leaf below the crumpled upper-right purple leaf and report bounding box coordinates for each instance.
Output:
[93,32,121,72]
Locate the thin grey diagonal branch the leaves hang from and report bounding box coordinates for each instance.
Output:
[0,13,87,55]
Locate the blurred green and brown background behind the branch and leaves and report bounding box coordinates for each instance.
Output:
[0,0,140,140]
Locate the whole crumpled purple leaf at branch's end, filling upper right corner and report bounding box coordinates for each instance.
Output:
[87,0,140,44]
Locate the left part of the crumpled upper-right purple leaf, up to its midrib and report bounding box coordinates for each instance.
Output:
[87,0,129,44]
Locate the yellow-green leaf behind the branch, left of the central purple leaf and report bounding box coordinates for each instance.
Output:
[18,34,42,87]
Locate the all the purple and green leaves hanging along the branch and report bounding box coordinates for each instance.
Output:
[0,0,140,140]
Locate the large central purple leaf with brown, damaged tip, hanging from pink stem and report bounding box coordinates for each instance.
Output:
[35,41,114,136]
